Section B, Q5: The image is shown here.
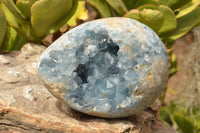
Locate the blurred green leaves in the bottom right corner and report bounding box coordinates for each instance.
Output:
[160,99,200,133]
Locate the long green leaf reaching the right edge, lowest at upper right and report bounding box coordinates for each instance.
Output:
[160,7,200,42]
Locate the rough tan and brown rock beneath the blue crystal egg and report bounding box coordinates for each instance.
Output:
[0,44,175,133]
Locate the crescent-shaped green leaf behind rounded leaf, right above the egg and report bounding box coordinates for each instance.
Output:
[158,5,177,33]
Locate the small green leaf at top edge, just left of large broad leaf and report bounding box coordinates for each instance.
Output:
[16,0,37,20]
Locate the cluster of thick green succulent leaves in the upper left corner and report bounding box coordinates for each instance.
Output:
[0,0,78,50]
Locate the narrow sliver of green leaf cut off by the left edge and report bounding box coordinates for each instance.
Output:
[0,9,6,47]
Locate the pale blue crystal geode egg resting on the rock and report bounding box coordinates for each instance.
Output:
[37,18,168,118]
